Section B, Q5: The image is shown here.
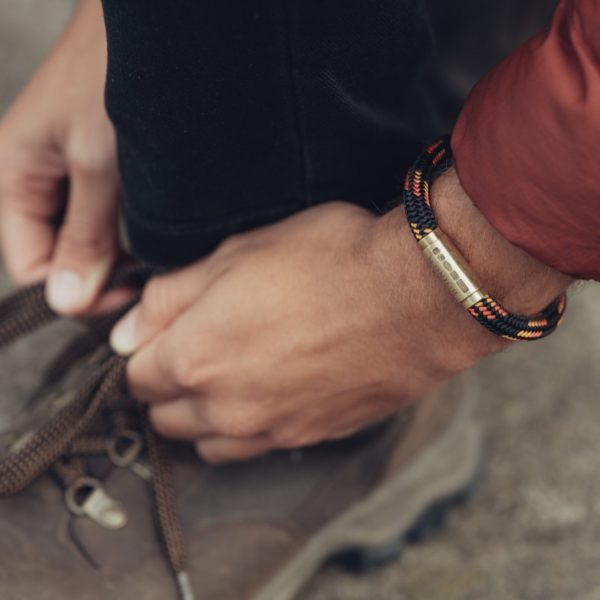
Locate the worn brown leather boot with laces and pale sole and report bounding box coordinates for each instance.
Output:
[0,278,481,600]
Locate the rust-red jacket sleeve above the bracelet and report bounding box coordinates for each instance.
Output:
[452,0,600,280]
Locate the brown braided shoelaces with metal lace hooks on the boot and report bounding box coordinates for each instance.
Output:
[0,265,193,600]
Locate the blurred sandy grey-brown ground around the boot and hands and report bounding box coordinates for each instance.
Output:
[0,0,600,600]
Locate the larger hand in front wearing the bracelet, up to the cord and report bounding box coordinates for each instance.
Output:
[112,170,568,462]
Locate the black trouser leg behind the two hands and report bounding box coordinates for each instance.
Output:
[104,0,555,266]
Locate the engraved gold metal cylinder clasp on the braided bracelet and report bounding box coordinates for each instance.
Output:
[419,228,486,308]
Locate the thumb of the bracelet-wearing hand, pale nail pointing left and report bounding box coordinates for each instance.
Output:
[110,260,207,356]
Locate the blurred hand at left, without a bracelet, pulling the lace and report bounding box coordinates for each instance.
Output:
[0,0,120,314]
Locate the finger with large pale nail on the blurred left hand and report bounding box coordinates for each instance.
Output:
[46,165,119,314]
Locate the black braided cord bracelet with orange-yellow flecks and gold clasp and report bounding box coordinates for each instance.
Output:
[403,137,567,341]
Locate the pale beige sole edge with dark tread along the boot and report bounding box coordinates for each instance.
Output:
[252,394,483,600]
